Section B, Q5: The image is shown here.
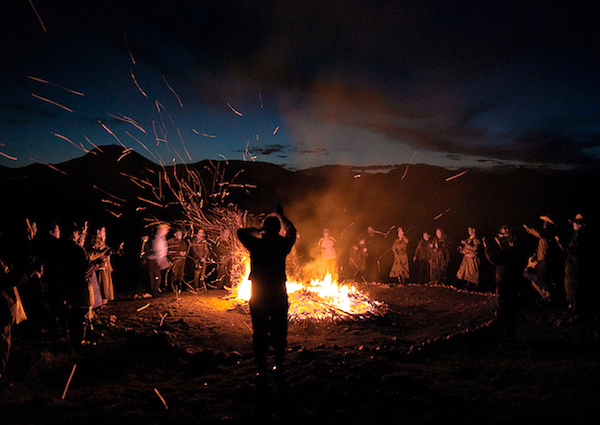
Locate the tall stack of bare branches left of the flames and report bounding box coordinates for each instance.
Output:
[165,162,259,286]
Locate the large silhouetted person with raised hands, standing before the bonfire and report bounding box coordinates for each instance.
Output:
[237,204,296,387]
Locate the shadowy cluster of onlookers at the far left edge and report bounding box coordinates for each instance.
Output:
[0,220,123,373]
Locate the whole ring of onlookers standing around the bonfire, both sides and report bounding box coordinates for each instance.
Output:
[0,213,593,380]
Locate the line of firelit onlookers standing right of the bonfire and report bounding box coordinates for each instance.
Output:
[319,214,597,340]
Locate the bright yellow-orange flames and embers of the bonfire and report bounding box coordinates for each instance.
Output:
[229,257,383,321]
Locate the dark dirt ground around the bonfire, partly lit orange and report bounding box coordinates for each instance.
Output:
[0,285,600,425]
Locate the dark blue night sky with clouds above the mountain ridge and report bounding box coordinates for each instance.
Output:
[0,0,600,169]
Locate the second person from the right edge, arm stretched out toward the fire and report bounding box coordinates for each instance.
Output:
[523,215,559,298]
